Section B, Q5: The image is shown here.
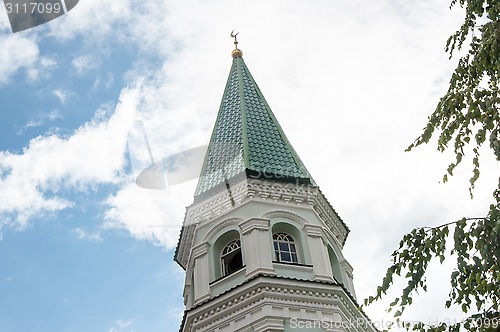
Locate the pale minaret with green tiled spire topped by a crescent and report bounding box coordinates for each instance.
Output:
[174,33,375,332]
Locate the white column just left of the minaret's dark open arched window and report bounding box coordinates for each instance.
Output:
[191,243,210,303]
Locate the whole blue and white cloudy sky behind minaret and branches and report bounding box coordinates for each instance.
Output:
[0,0,497,332]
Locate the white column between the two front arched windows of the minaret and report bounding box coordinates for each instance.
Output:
[239,218,275,278]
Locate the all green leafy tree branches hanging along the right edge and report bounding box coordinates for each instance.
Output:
[365,0,500,331]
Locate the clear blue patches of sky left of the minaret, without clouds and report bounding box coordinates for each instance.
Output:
[0,8,183,332]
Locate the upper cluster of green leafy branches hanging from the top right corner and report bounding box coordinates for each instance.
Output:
[407,0,500,194]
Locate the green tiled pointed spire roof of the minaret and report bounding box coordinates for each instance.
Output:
[195,49,316,197]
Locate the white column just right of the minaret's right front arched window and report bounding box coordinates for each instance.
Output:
[304,225,333,281]
